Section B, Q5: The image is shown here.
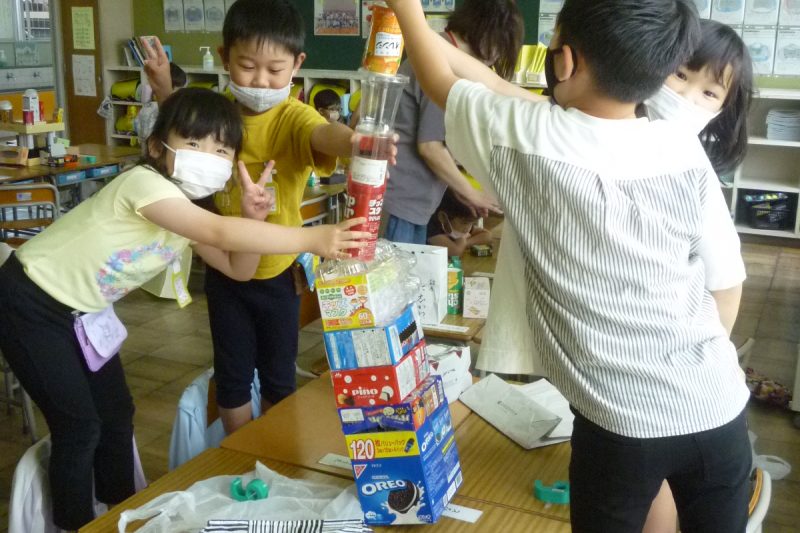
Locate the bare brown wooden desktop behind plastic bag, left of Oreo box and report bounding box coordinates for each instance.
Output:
[220,372,472,479]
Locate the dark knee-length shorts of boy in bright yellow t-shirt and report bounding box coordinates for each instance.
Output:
[205,268,300,409]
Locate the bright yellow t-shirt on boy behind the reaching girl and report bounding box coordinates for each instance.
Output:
[214,98,336,279]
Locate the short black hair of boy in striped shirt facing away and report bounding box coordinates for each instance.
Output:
[556,0,700,103]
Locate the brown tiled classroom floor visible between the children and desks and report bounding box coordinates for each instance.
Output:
[0,244,800,533]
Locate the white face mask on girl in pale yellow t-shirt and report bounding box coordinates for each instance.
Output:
[161,143,233,200]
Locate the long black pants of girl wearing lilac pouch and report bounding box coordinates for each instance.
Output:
[0,255,134,529]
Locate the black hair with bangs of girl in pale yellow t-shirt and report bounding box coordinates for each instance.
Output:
[143,87,244,175]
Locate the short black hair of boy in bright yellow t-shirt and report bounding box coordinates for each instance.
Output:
[222,0,306,57]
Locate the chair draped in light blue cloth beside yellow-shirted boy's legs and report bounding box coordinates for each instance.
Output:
[169,368,261,470]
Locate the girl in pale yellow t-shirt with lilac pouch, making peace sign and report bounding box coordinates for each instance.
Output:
[0,89,366,530]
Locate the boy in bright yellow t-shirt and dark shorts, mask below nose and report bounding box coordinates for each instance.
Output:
[145,0,394,433]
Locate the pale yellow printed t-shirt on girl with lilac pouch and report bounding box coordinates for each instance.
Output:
[17,166,189,313]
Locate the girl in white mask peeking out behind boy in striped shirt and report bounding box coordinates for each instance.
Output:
[428,14,753,533]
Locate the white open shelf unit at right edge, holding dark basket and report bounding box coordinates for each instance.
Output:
[725,89,800,239]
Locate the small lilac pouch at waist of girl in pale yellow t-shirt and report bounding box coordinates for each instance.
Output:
[73,306,128,372]
